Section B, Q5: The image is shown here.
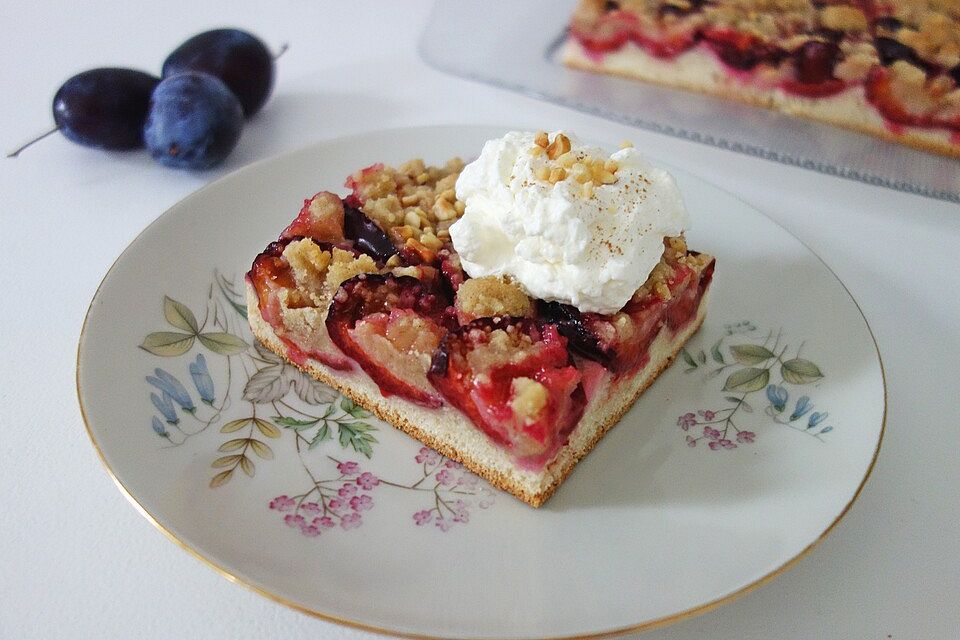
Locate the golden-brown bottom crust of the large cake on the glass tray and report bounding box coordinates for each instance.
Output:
[562,40,960,158]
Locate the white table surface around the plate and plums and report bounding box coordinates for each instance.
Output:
[0,0,960,640]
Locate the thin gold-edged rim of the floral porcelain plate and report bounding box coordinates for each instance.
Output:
[75,123,888,640]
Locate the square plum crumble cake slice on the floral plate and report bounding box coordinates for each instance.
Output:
[246,132,714,506]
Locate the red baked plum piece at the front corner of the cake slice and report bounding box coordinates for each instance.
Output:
[428,318,586,464]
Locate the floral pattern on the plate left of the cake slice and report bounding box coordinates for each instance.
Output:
[140,271,494,537]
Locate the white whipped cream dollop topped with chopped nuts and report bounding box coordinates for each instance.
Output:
[450,131,689,314]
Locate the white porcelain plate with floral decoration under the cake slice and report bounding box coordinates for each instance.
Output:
[77,126,885,638]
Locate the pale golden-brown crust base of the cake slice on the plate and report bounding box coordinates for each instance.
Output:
[247,284,709,507]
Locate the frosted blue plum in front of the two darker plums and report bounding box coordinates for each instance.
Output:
[144,73,243,169]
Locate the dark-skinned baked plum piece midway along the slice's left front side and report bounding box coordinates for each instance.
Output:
[326,274,450,407]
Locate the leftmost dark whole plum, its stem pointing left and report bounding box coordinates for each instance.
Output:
[53,67,160,149]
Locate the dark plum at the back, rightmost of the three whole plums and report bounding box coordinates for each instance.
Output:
[162,29,274,118]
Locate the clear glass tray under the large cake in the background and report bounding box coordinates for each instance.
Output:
[420,0,960,202]
